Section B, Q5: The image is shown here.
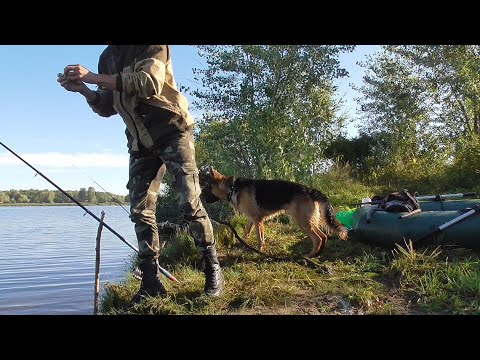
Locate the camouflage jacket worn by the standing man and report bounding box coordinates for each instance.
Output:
[88,45,193,151]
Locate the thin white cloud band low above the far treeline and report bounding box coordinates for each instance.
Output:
[0,152,128,168]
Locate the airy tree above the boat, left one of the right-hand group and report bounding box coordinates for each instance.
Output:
[357,47,429,163]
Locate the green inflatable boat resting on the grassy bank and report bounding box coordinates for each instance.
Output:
[337,193,480,249]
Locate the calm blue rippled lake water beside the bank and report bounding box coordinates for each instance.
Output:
[0,206,137,315]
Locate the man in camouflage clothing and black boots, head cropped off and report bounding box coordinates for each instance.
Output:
[57,45,223,303]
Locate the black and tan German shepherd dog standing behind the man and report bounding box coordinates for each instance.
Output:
[200,166,348,257]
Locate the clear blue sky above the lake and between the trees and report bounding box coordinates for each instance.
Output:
[0,45,380,195]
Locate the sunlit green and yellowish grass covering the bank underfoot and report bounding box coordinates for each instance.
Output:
[101,216,480,315]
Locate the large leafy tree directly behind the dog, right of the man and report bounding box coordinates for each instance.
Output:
[193,45,354,180]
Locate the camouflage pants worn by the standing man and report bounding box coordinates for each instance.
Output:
[127,125,215,259]
